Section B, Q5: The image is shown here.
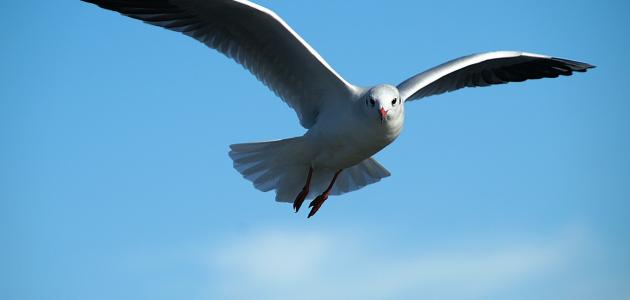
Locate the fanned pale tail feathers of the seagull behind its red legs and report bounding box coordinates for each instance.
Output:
[229,137,390,202]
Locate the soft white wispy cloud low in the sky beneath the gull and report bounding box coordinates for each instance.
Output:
[209,229,585,300]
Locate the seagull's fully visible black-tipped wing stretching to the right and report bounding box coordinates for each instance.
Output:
[398,51,594,101]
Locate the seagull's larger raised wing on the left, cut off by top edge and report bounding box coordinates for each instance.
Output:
[83,0,356,128]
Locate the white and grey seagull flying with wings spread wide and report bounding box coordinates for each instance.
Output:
[82,0,594,218]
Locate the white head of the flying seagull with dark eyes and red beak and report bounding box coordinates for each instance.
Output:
[363,84,403,124]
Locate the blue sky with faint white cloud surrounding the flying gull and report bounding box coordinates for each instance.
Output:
[0,0,630,300]
